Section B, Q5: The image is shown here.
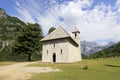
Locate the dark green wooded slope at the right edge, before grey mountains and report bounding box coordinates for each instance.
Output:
[91,42,120,58]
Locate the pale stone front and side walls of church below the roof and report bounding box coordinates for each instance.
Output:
[42,39,81,63]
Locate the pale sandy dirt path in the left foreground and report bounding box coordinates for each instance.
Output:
[0,62,60,80]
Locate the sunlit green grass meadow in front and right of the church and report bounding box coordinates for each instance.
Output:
[29,57,120,80]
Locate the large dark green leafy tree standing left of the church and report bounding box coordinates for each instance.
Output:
[12,23,43,61]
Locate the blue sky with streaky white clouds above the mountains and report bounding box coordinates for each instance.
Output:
[0,0,120,43]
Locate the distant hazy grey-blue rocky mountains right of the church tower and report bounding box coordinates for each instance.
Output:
[80,40,115,55]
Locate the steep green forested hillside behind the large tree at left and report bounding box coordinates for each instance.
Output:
[0,8,42,61]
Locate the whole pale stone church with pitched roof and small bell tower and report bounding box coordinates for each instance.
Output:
[41,27,81,63]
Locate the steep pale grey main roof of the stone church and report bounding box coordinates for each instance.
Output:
[40,26,78,45]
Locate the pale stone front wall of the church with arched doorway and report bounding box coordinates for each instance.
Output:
[42,39,69,63]
